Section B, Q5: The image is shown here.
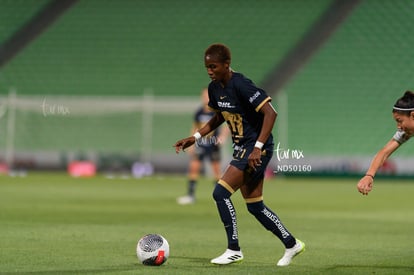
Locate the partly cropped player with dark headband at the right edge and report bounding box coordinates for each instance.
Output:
[357,91,414,195]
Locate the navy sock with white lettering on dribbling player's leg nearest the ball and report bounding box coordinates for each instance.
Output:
[213,184,240,250]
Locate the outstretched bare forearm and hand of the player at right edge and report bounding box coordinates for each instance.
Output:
[357,139,401,195]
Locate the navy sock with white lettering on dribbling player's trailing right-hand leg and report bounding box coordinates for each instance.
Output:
[247,201,296,248]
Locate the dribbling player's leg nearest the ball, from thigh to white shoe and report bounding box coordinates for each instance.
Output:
[211,165,243,264]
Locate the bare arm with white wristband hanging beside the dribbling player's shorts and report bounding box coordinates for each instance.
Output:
[248,102,277,169]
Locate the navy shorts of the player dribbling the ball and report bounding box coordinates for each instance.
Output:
[230,144,273,183]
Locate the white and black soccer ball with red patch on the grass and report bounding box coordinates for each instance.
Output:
[137,234,170,265]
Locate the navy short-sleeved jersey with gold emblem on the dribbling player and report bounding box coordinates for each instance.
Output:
[208,72,273,146]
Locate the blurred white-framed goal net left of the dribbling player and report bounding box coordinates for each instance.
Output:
[0,92,200,169]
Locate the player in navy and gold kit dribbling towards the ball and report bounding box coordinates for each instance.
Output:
[174,44,305,266]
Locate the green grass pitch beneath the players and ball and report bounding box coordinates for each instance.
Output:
[0,173,414,275]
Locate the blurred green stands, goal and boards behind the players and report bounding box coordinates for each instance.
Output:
[0,0,414,177]
